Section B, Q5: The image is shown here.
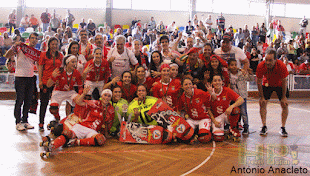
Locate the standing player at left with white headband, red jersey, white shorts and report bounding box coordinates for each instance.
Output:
[46,54,83,121]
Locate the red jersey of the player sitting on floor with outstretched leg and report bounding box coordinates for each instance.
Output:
[74,100,114,131]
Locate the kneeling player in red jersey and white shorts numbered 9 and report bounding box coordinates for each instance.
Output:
[177,78,215,143]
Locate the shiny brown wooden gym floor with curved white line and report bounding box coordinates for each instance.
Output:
[0,99,310,176]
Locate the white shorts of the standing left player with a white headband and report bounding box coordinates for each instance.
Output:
[51,90,78,106]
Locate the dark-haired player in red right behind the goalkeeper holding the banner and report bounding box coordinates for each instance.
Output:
[135,65,154,95]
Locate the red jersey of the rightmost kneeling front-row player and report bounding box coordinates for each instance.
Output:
[211,87,240,117]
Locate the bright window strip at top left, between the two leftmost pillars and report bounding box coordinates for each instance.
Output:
[25,0,106,8]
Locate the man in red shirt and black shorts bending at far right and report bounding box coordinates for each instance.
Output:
[256,49,289,137]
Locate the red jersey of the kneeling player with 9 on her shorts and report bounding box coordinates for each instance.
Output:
[177,89,211,120]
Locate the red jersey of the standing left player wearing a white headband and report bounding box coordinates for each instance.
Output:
[54,69,83,91]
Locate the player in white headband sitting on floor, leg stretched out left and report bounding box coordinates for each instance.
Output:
[44,86,114,151]
